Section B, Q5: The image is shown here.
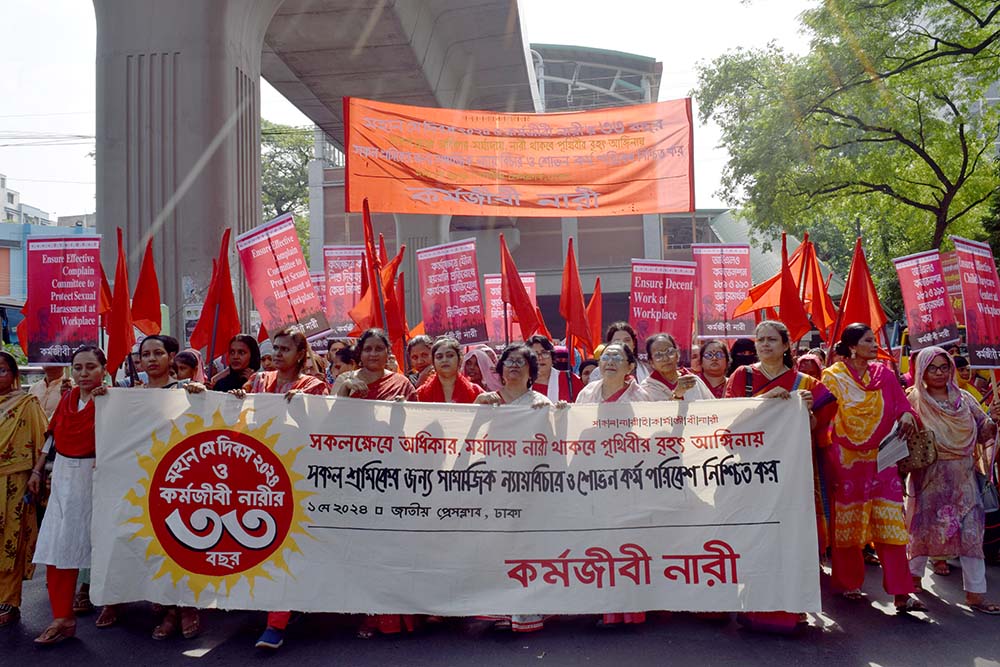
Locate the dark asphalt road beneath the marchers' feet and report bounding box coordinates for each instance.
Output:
[0,563,1000,667]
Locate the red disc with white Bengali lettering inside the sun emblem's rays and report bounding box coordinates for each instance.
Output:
[149,430,295,577]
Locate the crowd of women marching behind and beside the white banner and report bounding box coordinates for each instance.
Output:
[0,321,1000,649]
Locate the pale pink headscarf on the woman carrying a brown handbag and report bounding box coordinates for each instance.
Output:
[907,347,977,460]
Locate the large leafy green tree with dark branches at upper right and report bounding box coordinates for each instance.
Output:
[694,0,1000,292]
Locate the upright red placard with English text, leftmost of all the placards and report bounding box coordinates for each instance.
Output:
[21,236,101,365]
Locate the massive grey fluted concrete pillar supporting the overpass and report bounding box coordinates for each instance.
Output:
[94,0,283,331]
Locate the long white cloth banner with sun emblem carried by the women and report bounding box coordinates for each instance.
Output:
[92,389,820,616]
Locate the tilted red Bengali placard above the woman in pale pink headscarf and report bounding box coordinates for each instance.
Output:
[892,250,960,350]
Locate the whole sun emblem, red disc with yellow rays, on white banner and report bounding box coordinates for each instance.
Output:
[125,410,313,601]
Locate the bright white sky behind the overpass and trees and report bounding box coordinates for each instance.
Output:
[0,0,815,219]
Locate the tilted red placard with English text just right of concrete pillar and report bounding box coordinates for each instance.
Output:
[236,213,330,339]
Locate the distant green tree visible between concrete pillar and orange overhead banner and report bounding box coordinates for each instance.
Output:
[260,118,313,262]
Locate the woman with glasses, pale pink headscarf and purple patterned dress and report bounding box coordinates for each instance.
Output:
[906,347,1000,615]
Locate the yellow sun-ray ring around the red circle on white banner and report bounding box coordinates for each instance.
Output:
[123,409,315,601]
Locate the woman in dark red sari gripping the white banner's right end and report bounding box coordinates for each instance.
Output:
[725,320,837,632]
